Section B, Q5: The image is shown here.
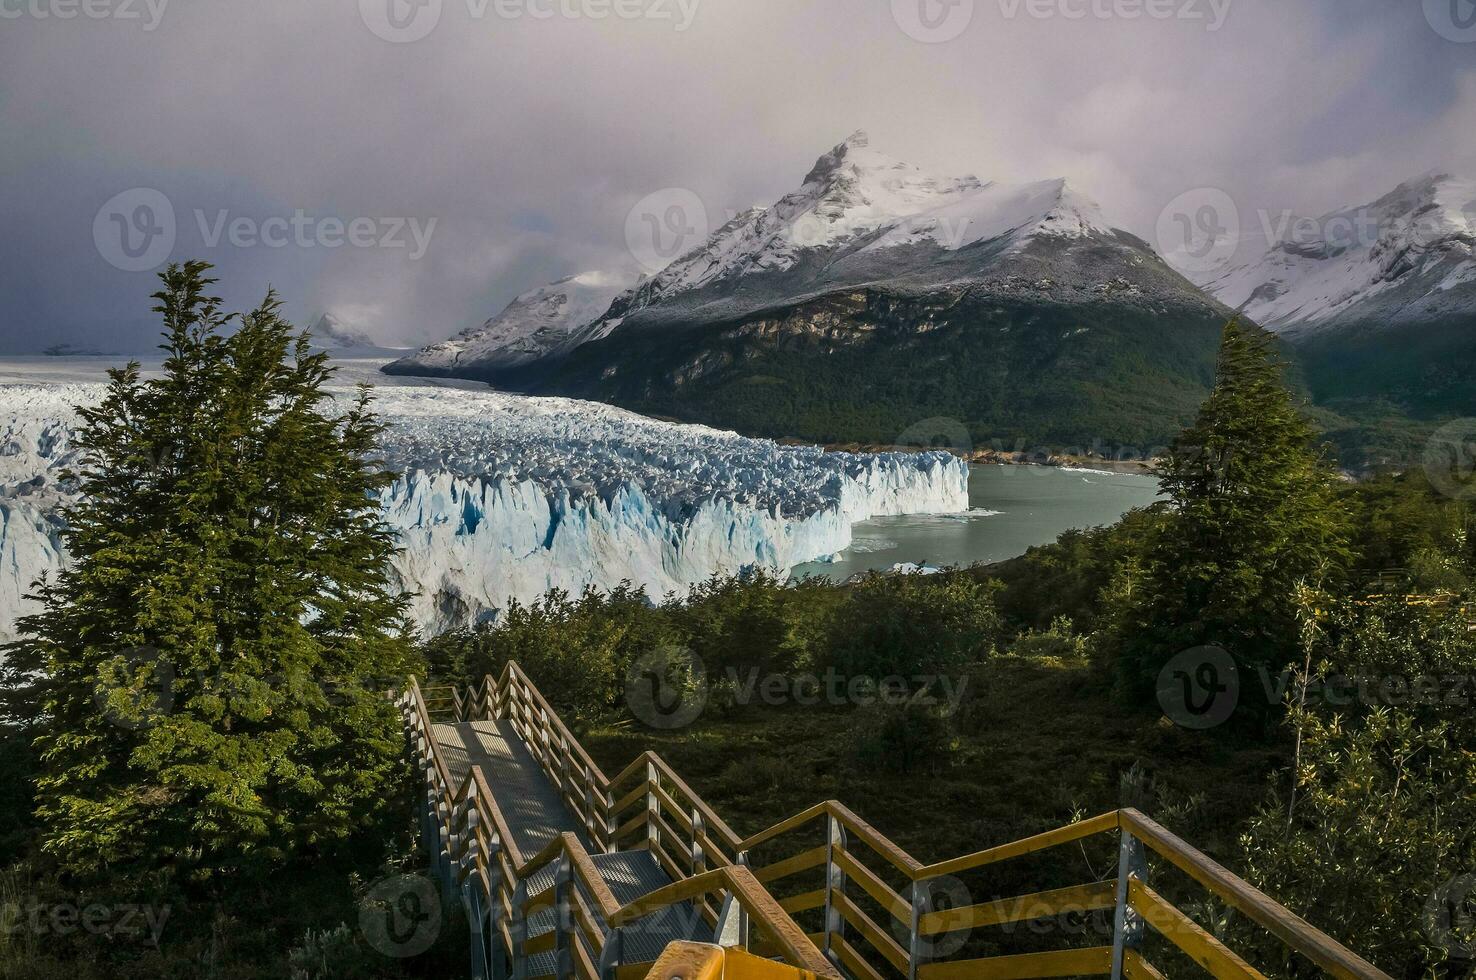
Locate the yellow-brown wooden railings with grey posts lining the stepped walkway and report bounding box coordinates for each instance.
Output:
[407,664,1389,980]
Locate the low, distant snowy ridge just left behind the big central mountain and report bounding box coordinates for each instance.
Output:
[384,272,639,376]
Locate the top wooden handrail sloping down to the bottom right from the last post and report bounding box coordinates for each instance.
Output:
[1119,809,1390,980]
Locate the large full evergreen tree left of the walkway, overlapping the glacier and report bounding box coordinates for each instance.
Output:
[6,261,410,881]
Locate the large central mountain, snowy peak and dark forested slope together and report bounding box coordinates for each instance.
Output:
[534,134,1228,447]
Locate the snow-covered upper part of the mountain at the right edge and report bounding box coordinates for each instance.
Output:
[1206,173,1476,334]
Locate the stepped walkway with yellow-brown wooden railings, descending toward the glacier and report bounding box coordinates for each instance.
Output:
[399,664,1389,980]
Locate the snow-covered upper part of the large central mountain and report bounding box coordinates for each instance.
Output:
[557,131,1133,348]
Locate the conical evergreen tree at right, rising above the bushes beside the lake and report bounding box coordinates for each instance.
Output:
[1116,320,1349,707]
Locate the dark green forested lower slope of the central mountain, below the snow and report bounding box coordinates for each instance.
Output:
[540,292,1221,445]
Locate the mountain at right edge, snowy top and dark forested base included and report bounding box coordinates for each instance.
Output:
[1207,173,1476,468]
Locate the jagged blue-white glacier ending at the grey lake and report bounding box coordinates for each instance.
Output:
[0,367,968,639]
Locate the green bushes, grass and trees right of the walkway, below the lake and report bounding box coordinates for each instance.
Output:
[434,325,1476,976]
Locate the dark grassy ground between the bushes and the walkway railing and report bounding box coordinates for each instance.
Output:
[583,657,1286,863]
